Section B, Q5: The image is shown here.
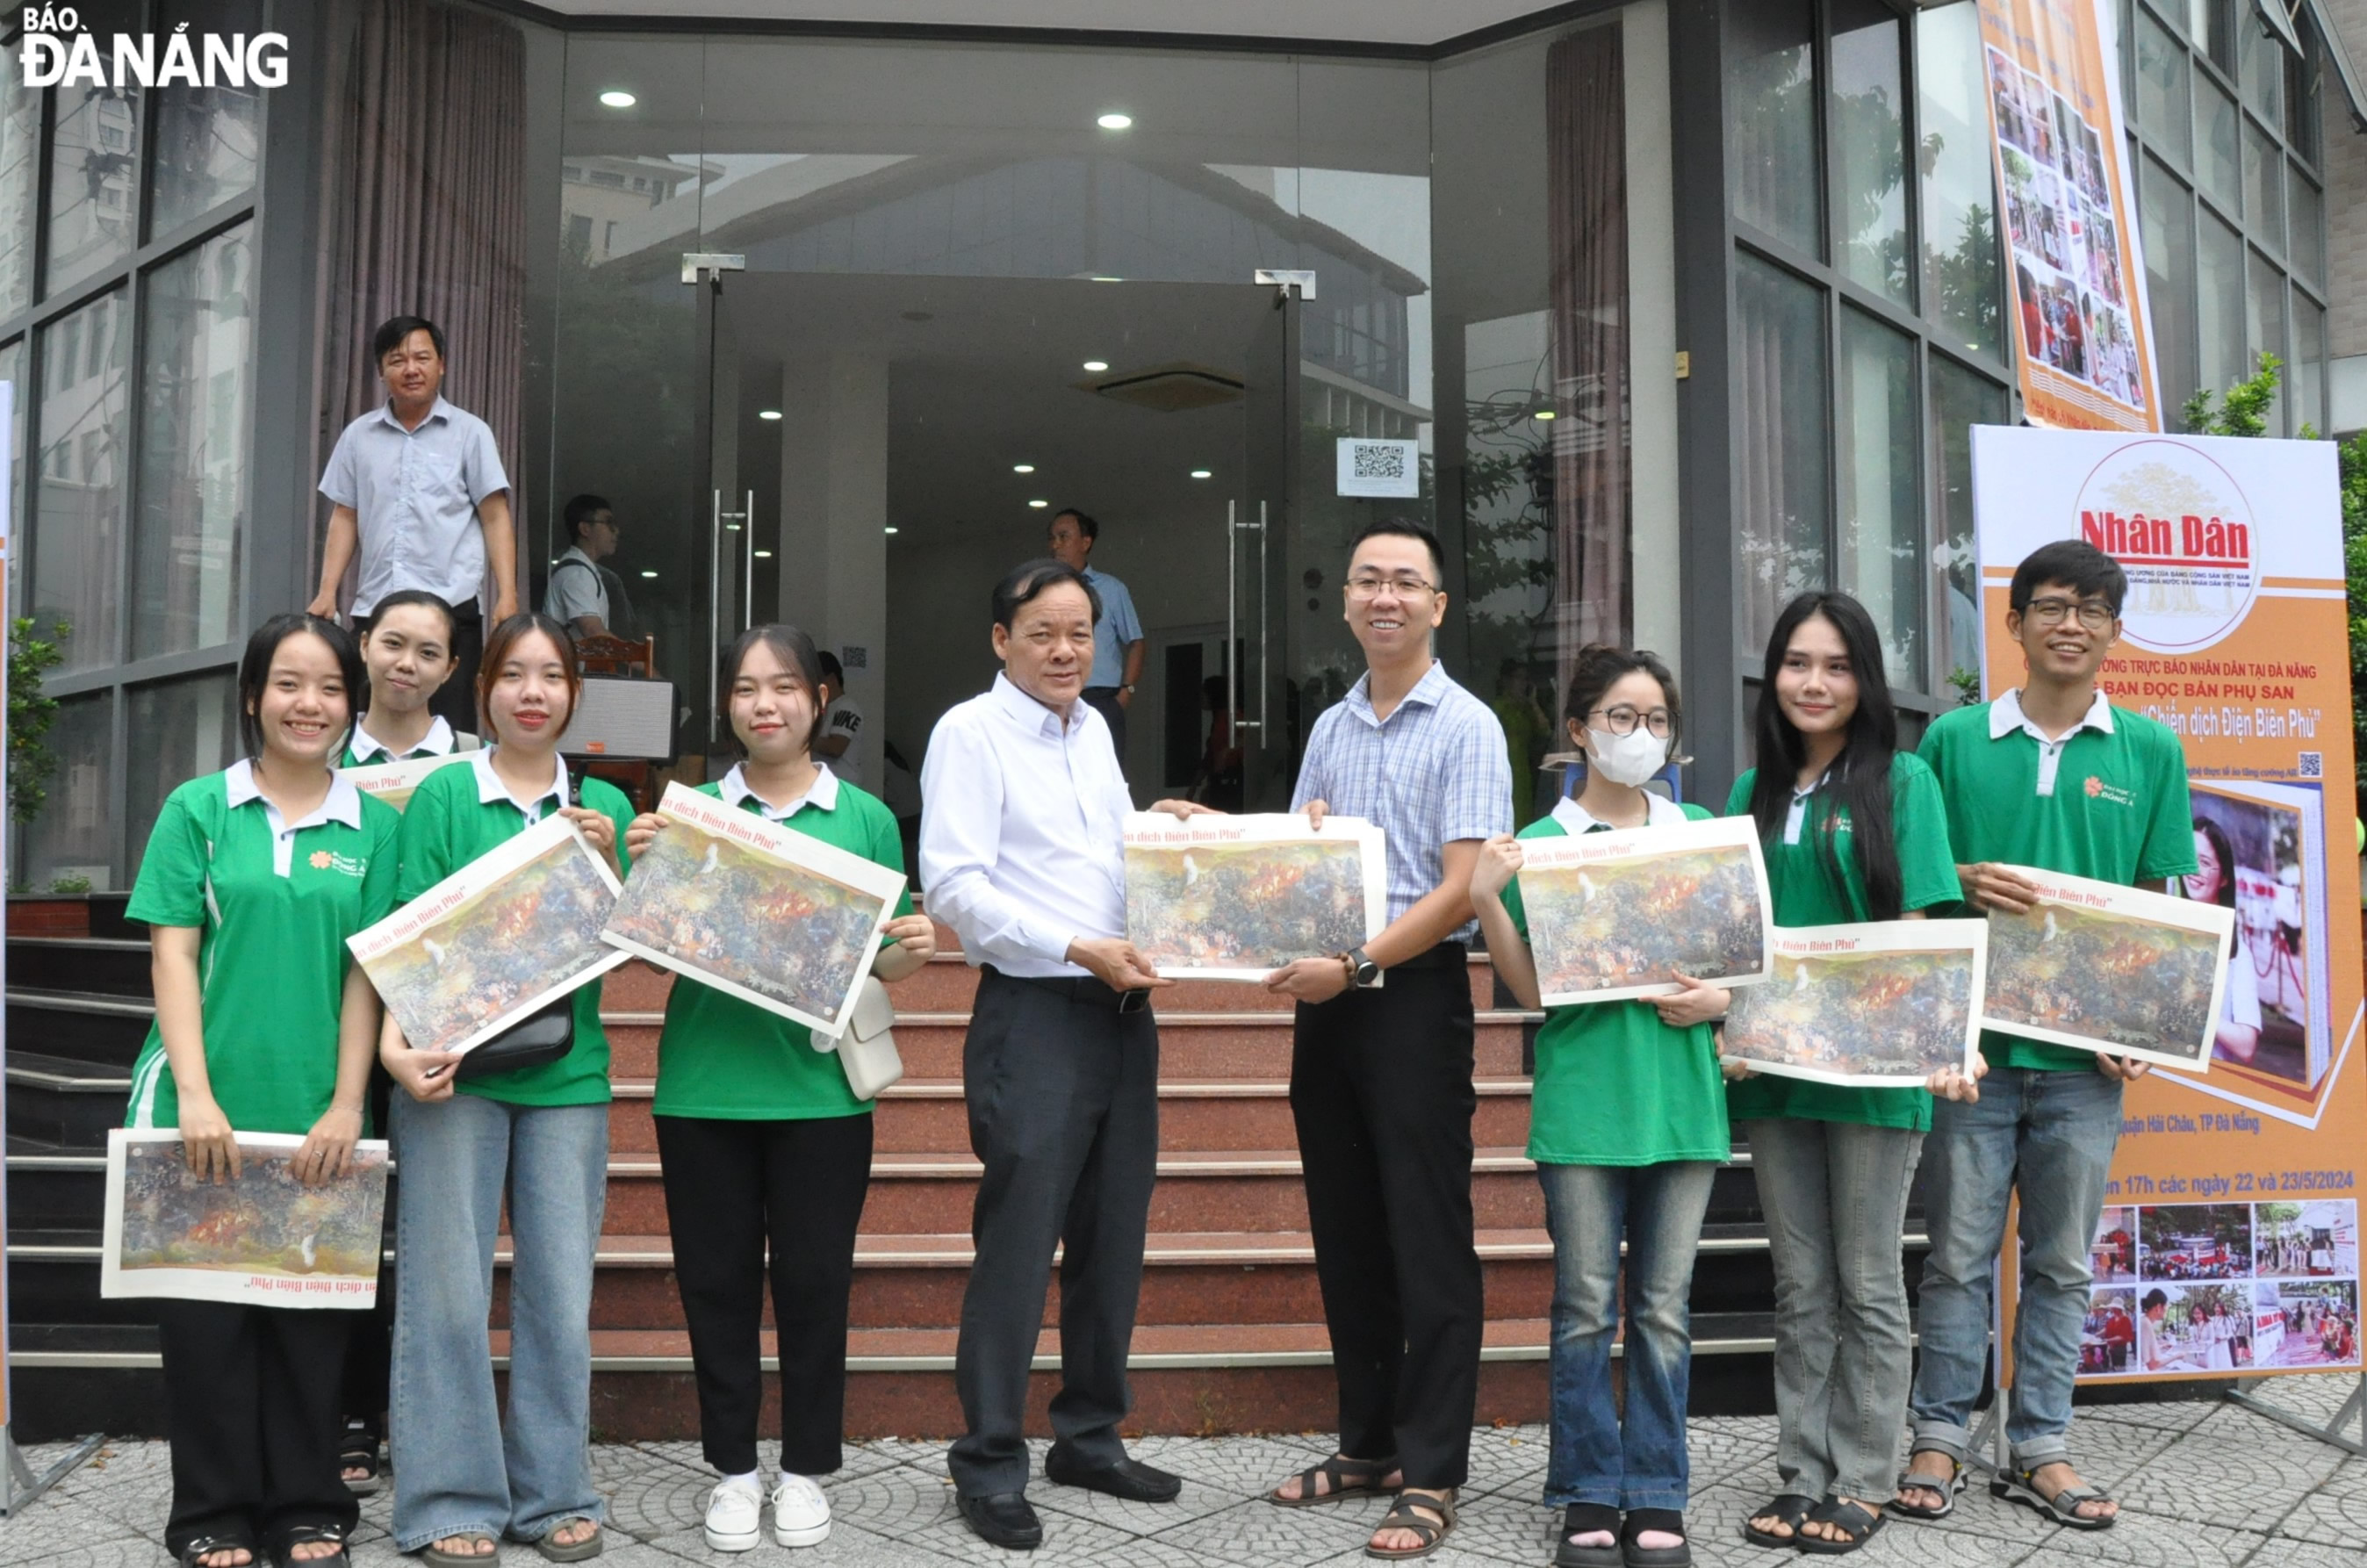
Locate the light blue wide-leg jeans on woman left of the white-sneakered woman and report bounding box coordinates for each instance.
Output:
[388,1092,608,1551]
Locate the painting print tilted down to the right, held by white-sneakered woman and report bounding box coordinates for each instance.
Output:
[601,784,904,1035]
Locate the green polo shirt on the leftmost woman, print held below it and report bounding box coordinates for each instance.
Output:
[123,763,402,1134]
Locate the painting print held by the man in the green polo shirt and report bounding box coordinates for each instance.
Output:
[1982,867,2234,1073]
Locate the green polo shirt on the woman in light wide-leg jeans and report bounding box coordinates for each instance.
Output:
[395,749,632,1106]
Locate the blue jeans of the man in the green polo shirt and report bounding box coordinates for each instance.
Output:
[1908,1068,2121,1469]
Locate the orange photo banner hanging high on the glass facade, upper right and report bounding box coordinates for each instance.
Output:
[1982,0,2161,431]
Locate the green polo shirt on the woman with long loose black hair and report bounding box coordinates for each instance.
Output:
[1725,751,1965,1133]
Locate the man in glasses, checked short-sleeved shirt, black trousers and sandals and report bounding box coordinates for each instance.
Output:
[1266,521,1513,1554]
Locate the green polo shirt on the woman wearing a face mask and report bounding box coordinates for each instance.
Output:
[1503,801,1732,1165]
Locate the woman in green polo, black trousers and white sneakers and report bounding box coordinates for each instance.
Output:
[625,625,938,1551]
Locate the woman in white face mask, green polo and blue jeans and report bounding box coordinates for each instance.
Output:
[1472,644,1730,1568]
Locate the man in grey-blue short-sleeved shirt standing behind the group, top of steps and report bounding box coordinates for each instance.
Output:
[306,315,518,730]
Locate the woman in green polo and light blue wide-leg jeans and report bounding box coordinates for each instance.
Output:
[378,614,632,1568]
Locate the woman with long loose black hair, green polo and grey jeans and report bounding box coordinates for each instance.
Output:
[1725,592,1974,1554]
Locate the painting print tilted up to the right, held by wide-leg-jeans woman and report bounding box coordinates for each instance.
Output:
[346,815,627,1052]
